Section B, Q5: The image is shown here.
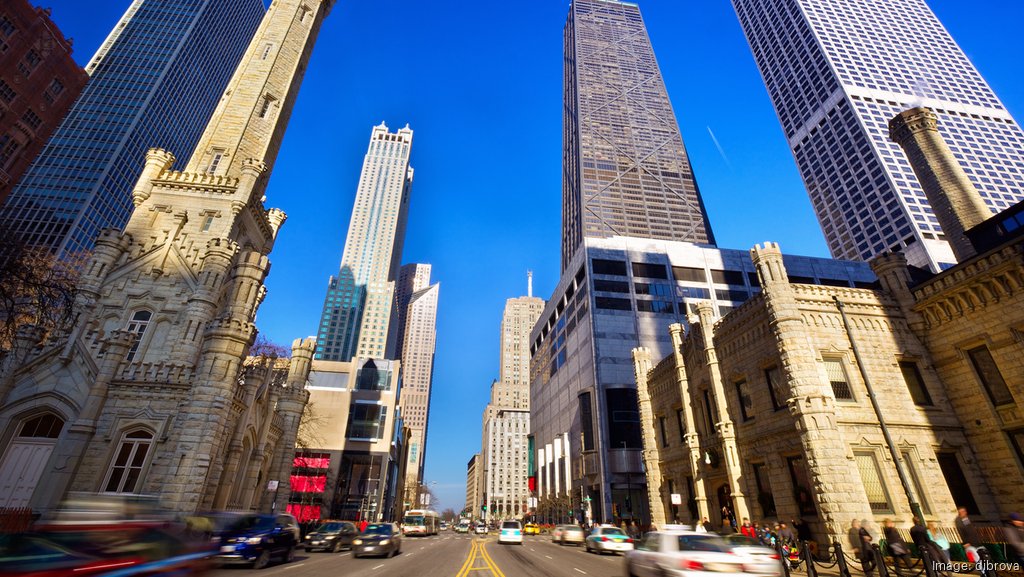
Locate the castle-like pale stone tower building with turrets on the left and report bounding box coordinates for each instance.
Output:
[0,0,332,512]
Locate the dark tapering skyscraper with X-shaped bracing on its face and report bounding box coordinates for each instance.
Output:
[562,0,715,270]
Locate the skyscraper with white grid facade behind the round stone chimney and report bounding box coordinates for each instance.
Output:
[733,0,1024,270]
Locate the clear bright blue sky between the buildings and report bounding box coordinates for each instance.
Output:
[48,0,1024,509]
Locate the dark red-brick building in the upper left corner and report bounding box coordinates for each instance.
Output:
[0,0,89,205]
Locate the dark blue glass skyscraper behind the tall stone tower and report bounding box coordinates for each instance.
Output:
[0,0,265,254]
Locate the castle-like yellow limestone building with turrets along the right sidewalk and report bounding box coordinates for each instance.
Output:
[634,235,1024,540]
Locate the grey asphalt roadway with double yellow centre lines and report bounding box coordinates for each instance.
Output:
[211,533,624,577]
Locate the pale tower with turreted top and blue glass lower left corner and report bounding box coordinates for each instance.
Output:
[316,122,413,361]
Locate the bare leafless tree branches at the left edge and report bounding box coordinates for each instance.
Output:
[0,230,88,351]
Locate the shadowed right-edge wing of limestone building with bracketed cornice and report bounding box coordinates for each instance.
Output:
[913,242,1024,522]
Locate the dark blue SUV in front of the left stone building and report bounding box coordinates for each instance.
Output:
[216,514,301,569]
